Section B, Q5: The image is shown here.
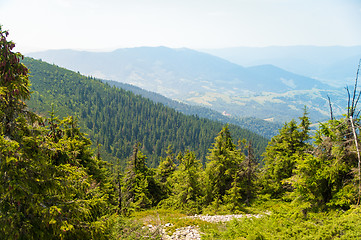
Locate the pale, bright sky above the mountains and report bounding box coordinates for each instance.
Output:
[0,0,361,53]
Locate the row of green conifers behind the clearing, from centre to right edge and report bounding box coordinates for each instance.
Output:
[119,102,361,215]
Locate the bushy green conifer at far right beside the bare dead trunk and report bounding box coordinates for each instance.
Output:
[293,119,358,209]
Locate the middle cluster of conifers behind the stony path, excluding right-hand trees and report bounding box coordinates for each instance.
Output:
[118,126,260,215]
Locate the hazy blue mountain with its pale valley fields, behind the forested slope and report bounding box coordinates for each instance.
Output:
[29,47,347,122]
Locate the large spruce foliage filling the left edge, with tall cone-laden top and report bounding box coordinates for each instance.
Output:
[0,26,113,239]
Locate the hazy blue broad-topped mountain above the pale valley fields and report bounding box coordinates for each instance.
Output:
[29,47,328,94]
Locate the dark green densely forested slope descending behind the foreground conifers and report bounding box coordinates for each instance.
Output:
[24,58,267,166]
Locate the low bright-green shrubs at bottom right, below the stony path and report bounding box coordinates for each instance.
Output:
[201,203,361,240]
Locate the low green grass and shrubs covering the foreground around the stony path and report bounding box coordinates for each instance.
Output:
[116,201,361,240]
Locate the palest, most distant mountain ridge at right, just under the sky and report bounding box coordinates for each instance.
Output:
[202,46,361,87]
